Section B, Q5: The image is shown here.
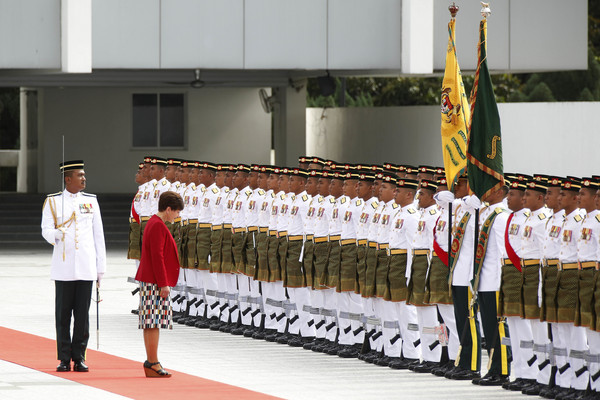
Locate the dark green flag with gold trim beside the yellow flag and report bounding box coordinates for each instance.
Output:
[467,19,504,200]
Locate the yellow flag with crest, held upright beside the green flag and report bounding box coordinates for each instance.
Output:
[441,18,471,190]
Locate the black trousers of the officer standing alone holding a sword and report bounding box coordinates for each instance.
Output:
[54,281,94,362]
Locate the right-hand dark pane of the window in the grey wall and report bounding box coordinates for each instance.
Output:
[160,94,184,147]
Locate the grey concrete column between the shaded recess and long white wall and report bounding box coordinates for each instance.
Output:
[273,80,306,167]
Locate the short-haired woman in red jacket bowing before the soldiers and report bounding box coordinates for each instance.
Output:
[135,191,183,378]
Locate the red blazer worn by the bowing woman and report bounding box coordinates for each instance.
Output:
[135,215,179,287]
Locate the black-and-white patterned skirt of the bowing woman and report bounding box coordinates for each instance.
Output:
[138,282,173,329]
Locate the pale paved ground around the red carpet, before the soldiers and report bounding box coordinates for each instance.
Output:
[0,248,525,400]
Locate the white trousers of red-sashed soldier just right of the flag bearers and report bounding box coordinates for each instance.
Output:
[504,317,539,379]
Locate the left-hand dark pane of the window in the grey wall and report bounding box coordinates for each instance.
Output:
[132,94,158,147]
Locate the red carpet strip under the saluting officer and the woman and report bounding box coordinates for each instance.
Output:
[0,327,276,400]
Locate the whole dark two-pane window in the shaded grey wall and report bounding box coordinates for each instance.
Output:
[132,93,185,148]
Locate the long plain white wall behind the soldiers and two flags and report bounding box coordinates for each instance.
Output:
[306,102,600,177]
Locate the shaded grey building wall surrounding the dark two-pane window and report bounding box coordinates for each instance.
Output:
[38,88,271,193]
